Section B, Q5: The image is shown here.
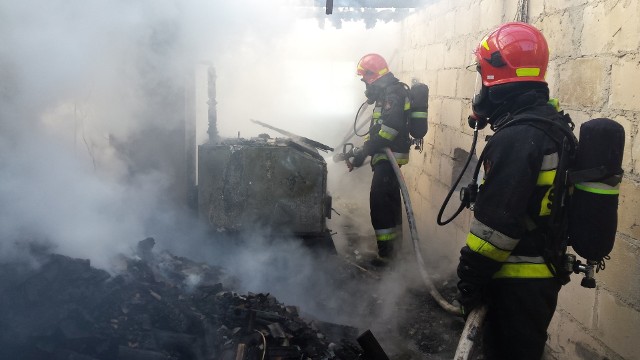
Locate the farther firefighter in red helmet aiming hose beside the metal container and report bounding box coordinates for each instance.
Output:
[347,54,410,266]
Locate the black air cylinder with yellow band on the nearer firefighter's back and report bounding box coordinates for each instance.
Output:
[568,118,625,262]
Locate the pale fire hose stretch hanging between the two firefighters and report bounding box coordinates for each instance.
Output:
[384,147,462,315]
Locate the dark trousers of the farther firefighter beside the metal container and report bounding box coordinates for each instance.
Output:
[369,160,402,258]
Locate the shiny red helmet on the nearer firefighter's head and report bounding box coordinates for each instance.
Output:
[474,22,549,87]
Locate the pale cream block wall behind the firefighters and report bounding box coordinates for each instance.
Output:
[391,0,640,360]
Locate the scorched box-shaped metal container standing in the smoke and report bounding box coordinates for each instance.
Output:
[197,137,331,238]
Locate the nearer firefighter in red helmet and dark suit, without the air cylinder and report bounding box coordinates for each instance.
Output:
[457,22,573,360]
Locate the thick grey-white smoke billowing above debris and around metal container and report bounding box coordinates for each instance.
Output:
[0,0,416,330]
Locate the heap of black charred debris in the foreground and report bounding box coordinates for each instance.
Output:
[0,238,361,360]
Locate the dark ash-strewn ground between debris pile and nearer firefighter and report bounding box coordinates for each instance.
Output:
[330,232,464,359]
